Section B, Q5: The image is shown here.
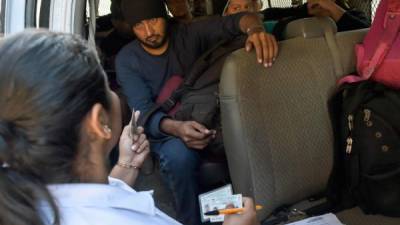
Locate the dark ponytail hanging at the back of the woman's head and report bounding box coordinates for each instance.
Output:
[0,120,60,225]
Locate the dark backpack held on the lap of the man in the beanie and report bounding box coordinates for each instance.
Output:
[138,36,246,159]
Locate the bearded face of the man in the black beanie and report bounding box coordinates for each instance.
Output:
[132,17,167,49]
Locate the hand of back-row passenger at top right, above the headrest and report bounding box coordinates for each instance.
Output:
[307,0,346,22]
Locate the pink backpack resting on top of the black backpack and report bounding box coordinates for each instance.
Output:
[339,0,400,89]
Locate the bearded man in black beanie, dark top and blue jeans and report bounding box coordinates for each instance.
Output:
[116,0,278,225]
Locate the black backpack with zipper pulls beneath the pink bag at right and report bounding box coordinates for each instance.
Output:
[328,81,400,217]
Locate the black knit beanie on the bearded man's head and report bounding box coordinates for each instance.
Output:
[121,0,167,26]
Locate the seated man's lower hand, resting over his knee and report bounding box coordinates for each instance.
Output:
[177,121,216,150]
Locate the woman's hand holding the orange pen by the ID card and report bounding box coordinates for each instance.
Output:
[223,197,259,225]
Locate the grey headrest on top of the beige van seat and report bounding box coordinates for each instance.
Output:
[284,17,337,39]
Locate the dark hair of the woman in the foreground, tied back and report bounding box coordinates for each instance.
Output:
[0,31,110,225]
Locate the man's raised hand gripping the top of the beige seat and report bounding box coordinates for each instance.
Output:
[246,31,278,67]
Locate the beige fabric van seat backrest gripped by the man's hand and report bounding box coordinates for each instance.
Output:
[220,18,366,218]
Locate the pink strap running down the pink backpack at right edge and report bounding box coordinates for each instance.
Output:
[361,0,400,80]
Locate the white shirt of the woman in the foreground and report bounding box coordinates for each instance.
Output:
[40,177,180,225]
